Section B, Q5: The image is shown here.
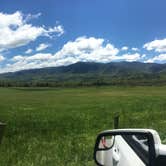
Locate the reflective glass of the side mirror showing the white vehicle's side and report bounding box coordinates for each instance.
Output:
[96,133,149,166]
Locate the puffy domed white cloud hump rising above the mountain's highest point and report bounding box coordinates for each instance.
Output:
[55,37,119,62]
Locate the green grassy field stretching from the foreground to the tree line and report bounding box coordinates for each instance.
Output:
[0,87,166,166]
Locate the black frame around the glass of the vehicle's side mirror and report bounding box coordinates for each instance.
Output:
[93,130,156,166]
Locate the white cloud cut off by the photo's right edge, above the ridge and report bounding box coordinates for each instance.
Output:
[143,39,166,52]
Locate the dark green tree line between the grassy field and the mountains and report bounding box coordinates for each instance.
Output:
[0,76,166,87]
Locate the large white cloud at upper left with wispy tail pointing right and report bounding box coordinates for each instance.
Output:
[0,11,64,50]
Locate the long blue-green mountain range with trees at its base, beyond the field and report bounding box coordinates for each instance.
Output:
[0,62,166,86]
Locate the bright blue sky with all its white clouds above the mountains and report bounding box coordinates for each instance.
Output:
[0,0,166,73]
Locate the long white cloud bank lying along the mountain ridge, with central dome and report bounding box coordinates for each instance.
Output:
[0,36,144,73]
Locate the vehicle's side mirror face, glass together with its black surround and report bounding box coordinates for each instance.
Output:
[94,129,156,166]
